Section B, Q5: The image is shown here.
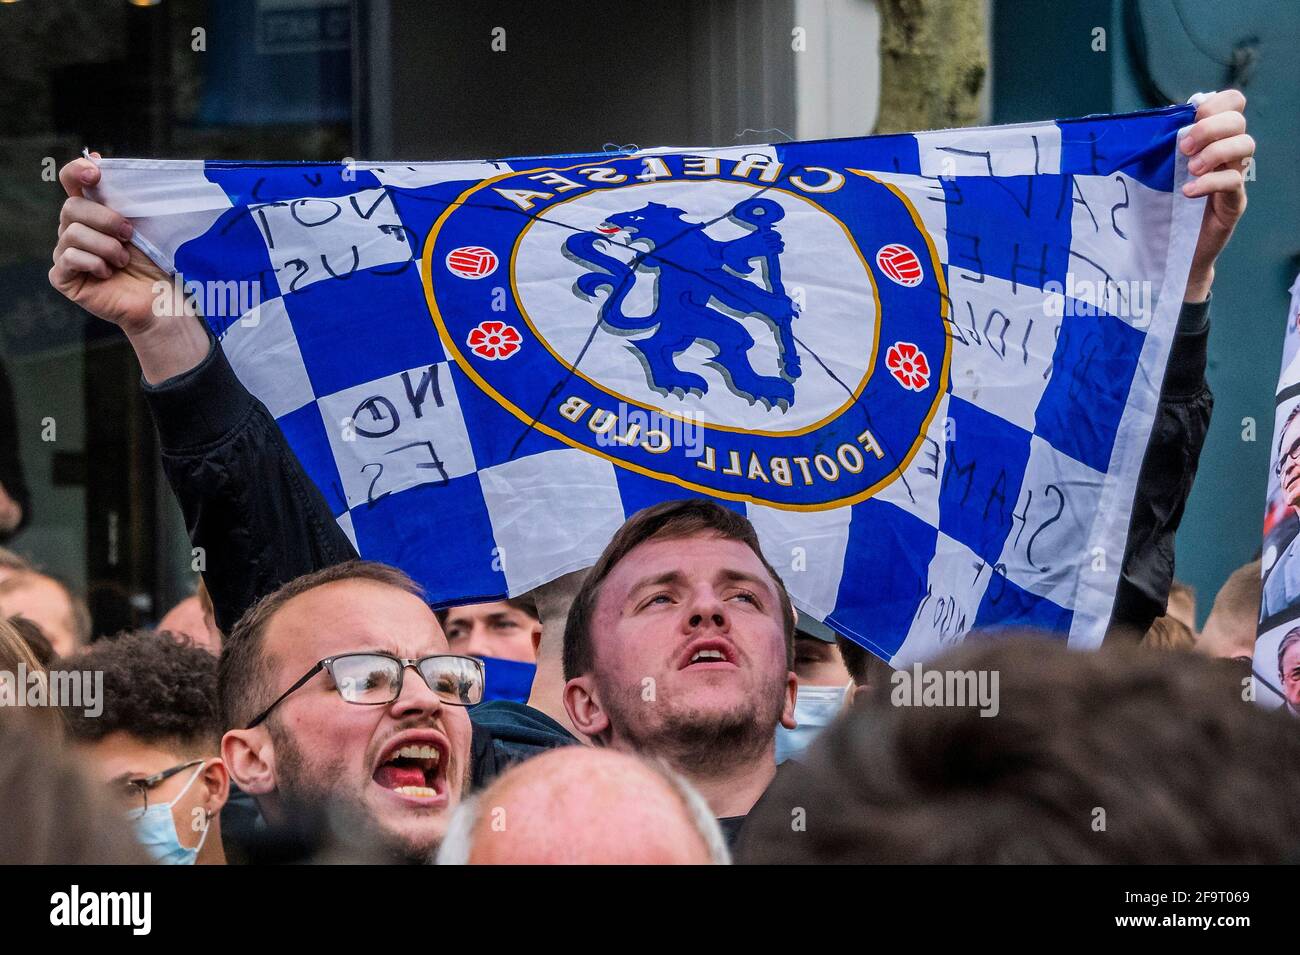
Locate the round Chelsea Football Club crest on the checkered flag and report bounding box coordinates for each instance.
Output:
[423,152,952,509]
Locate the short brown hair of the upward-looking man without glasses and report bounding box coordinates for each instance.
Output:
[564,498,794,680]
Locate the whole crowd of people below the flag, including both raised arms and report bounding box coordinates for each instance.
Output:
[0,91,1300,864]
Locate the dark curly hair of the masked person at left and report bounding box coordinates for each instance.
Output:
[66,630,224,750]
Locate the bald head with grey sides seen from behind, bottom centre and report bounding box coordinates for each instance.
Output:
[438,746,729,865]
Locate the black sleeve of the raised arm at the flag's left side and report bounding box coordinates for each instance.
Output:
[142,335,356,633]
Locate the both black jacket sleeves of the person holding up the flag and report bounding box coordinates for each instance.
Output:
[143,303,1214,635]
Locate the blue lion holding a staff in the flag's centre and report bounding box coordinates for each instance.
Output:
[564,199,800,411]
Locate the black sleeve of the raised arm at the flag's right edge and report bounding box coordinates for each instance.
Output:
[1109,300,1214,639]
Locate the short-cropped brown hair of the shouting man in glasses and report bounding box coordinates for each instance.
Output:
[217,560,424,729]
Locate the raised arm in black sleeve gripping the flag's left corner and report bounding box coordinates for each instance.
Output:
[49,159,356,631]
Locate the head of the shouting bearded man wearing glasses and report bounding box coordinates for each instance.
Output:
[218,561,481,859]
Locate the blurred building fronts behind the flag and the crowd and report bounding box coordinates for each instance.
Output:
[0,0,1300,633]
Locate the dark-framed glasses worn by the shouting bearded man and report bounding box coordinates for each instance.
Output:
[244,652,484,729]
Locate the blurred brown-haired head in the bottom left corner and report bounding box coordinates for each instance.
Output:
[0,707,146,865]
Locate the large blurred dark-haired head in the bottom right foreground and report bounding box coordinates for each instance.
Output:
[738,639,1300,864]
